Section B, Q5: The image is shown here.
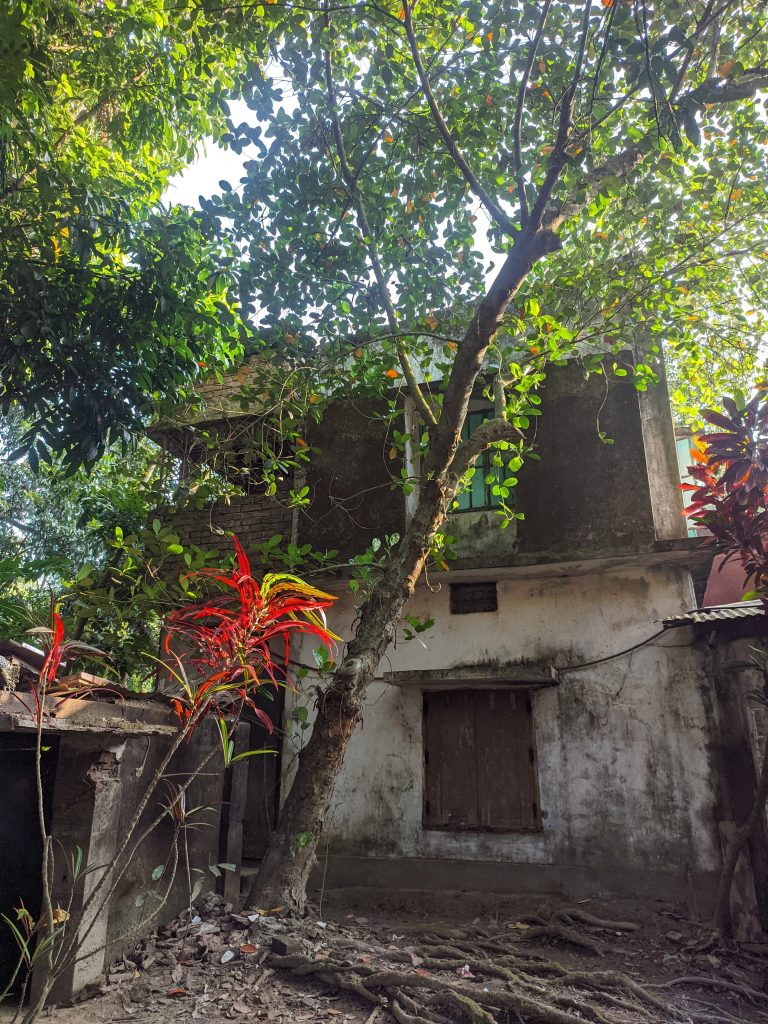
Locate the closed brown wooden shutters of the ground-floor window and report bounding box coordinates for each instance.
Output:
[424,688,540,831]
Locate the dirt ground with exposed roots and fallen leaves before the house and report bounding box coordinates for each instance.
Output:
[10,890,768,1024]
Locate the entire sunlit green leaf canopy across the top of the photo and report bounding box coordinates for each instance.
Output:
[0,0,768,600]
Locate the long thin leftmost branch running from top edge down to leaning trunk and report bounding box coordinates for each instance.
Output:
[325,5,437,426]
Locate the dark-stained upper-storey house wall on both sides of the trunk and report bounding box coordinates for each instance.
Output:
[157,362,685,568]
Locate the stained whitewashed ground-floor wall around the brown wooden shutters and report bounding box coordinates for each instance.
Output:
[284,568,719,894]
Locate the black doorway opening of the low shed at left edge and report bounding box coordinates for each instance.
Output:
[0,732,58,991]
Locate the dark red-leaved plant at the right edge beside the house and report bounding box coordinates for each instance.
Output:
[682,383,768,607]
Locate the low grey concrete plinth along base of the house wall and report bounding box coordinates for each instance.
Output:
[311,854,718,912]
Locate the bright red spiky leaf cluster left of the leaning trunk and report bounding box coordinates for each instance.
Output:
[164,537,338,763]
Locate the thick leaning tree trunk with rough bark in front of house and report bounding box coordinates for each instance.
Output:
[247,223,560,912]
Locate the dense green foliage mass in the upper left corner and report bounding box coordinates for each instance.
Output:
[0,0,274,471]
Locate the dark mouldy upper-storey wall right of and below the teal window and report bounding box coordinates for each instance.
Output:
[449,362,663,568]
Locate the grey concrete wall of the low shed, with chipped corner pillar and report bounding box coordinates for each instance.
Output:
[0,701,234,1002]
